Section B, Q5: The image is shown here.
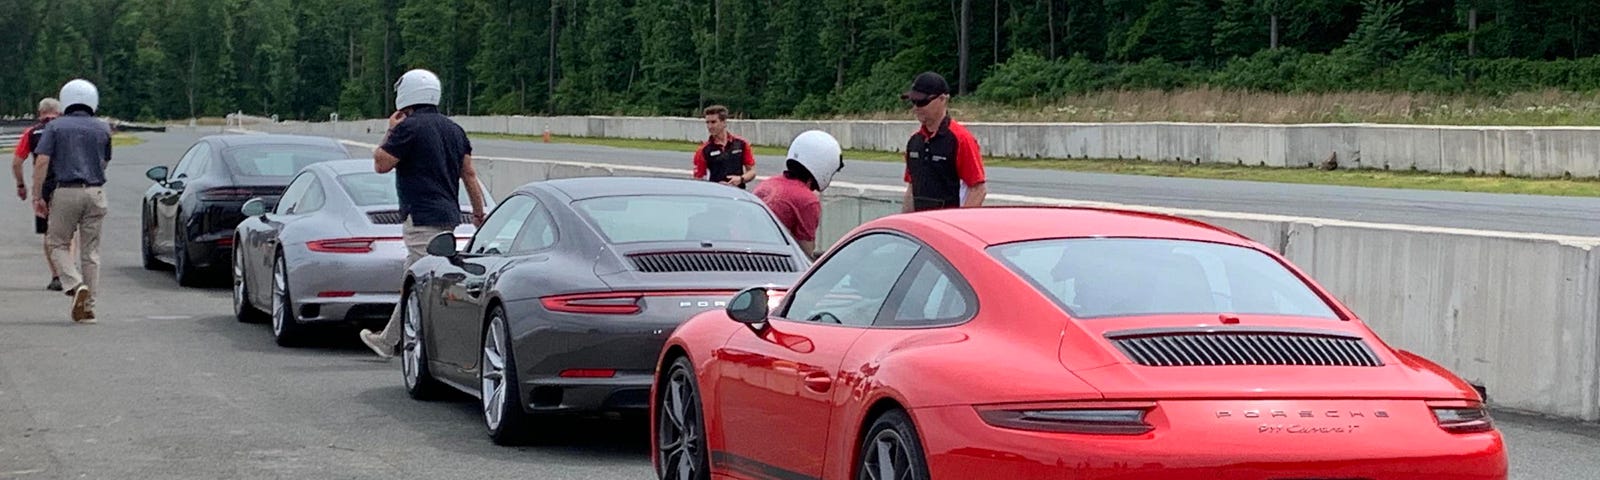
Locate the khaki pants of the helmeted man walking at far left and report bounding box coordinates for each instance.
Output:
[45,187,106,306]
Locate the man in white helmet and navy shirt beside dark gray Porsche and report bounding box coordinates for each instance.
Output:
[360,69,485,358]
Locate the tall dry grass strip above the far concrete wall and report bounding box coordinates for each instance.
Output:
[837,88,1600,126]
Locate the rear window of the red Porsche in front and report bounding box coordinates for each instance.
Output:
[989,238,1338,318]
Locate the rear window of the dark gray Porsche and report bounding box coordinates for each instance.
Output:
[573,195,786,245]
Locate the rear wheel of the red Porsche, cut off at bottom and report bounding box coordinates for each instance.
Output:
[856,410,928,480]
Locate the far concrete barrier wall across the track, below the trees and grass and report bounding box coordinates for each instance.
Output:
[179,117,1600,178]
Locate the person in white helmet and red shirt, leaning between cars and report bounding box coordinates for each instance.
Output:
[752,130,845,259]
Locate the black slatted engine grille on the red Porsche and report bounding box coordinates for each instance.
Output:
[1110,331,1384,366]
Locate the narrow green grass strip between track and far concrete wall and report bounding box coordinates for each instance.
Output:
[472,134,1600,197]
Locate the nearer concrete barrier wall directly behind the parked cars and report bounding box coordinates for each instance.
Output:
[451,152,1600,421]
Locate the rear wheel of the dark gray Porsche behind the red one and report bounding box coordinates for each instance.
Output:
[478,306,531,445]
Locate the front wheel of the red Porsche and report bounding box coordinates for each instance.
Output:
[654,357,710,480]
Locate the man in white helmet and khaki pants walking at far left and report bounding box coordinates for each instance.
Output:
[34,78,110,323]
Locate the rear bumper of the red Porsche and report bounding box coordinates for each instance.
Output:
[914,400,1507,480]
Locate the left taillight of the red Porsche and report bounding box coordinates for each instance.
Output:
[978,402,1155,435]
